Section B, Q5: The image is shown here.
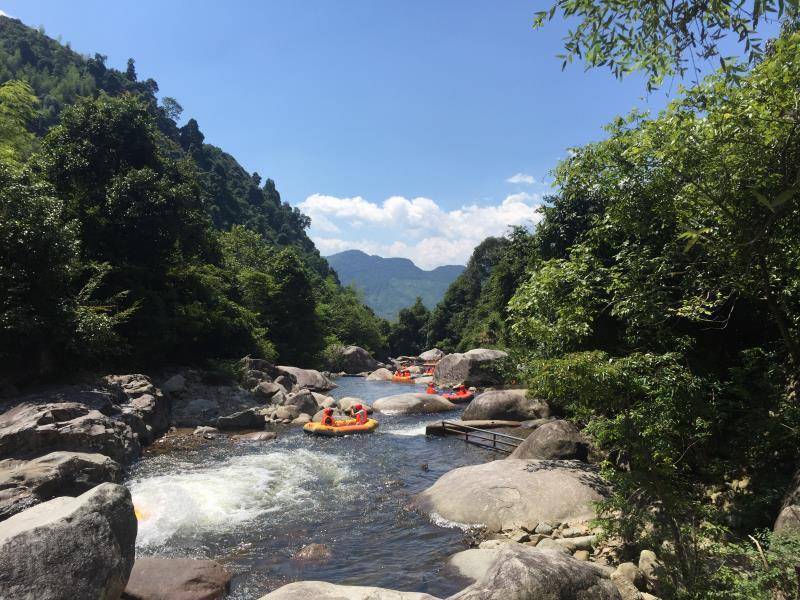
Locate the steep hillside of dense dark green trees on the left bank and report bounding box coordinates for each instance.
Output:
[0,17,385,376]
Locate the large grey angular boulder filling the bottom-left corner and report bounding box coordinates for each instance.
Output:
[0,483,136,600]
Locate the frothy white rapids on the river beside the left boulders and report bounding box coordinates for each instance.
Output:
[129,449,357,547]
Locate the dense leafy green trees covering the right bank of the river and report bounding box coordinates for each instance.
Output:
[429,24,800,598]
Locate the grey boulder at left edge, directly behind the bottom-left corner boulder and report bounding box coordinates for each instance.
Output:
[0,452,122,521]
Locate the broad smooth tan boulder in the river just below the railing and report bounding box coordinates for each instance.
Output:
[412,458,606,531]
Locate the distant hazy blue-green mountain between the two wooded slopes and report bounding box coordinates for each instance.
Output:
[327,250,464,320]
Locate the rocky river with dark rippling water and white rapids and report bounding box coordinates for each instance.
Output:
[127,377,497,600]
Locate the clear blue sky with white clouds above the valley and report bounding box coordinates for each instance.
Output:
[0,0,780,268]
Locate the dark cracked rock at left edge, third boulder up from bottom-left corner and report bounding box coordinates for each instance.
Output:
[0,402,141,464]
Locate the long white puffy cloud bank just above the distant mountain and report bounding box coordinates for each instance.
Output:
[300,192,541,269]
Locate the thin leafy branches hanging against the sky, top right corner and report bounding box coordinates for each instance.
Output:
[533,0,798,89]
